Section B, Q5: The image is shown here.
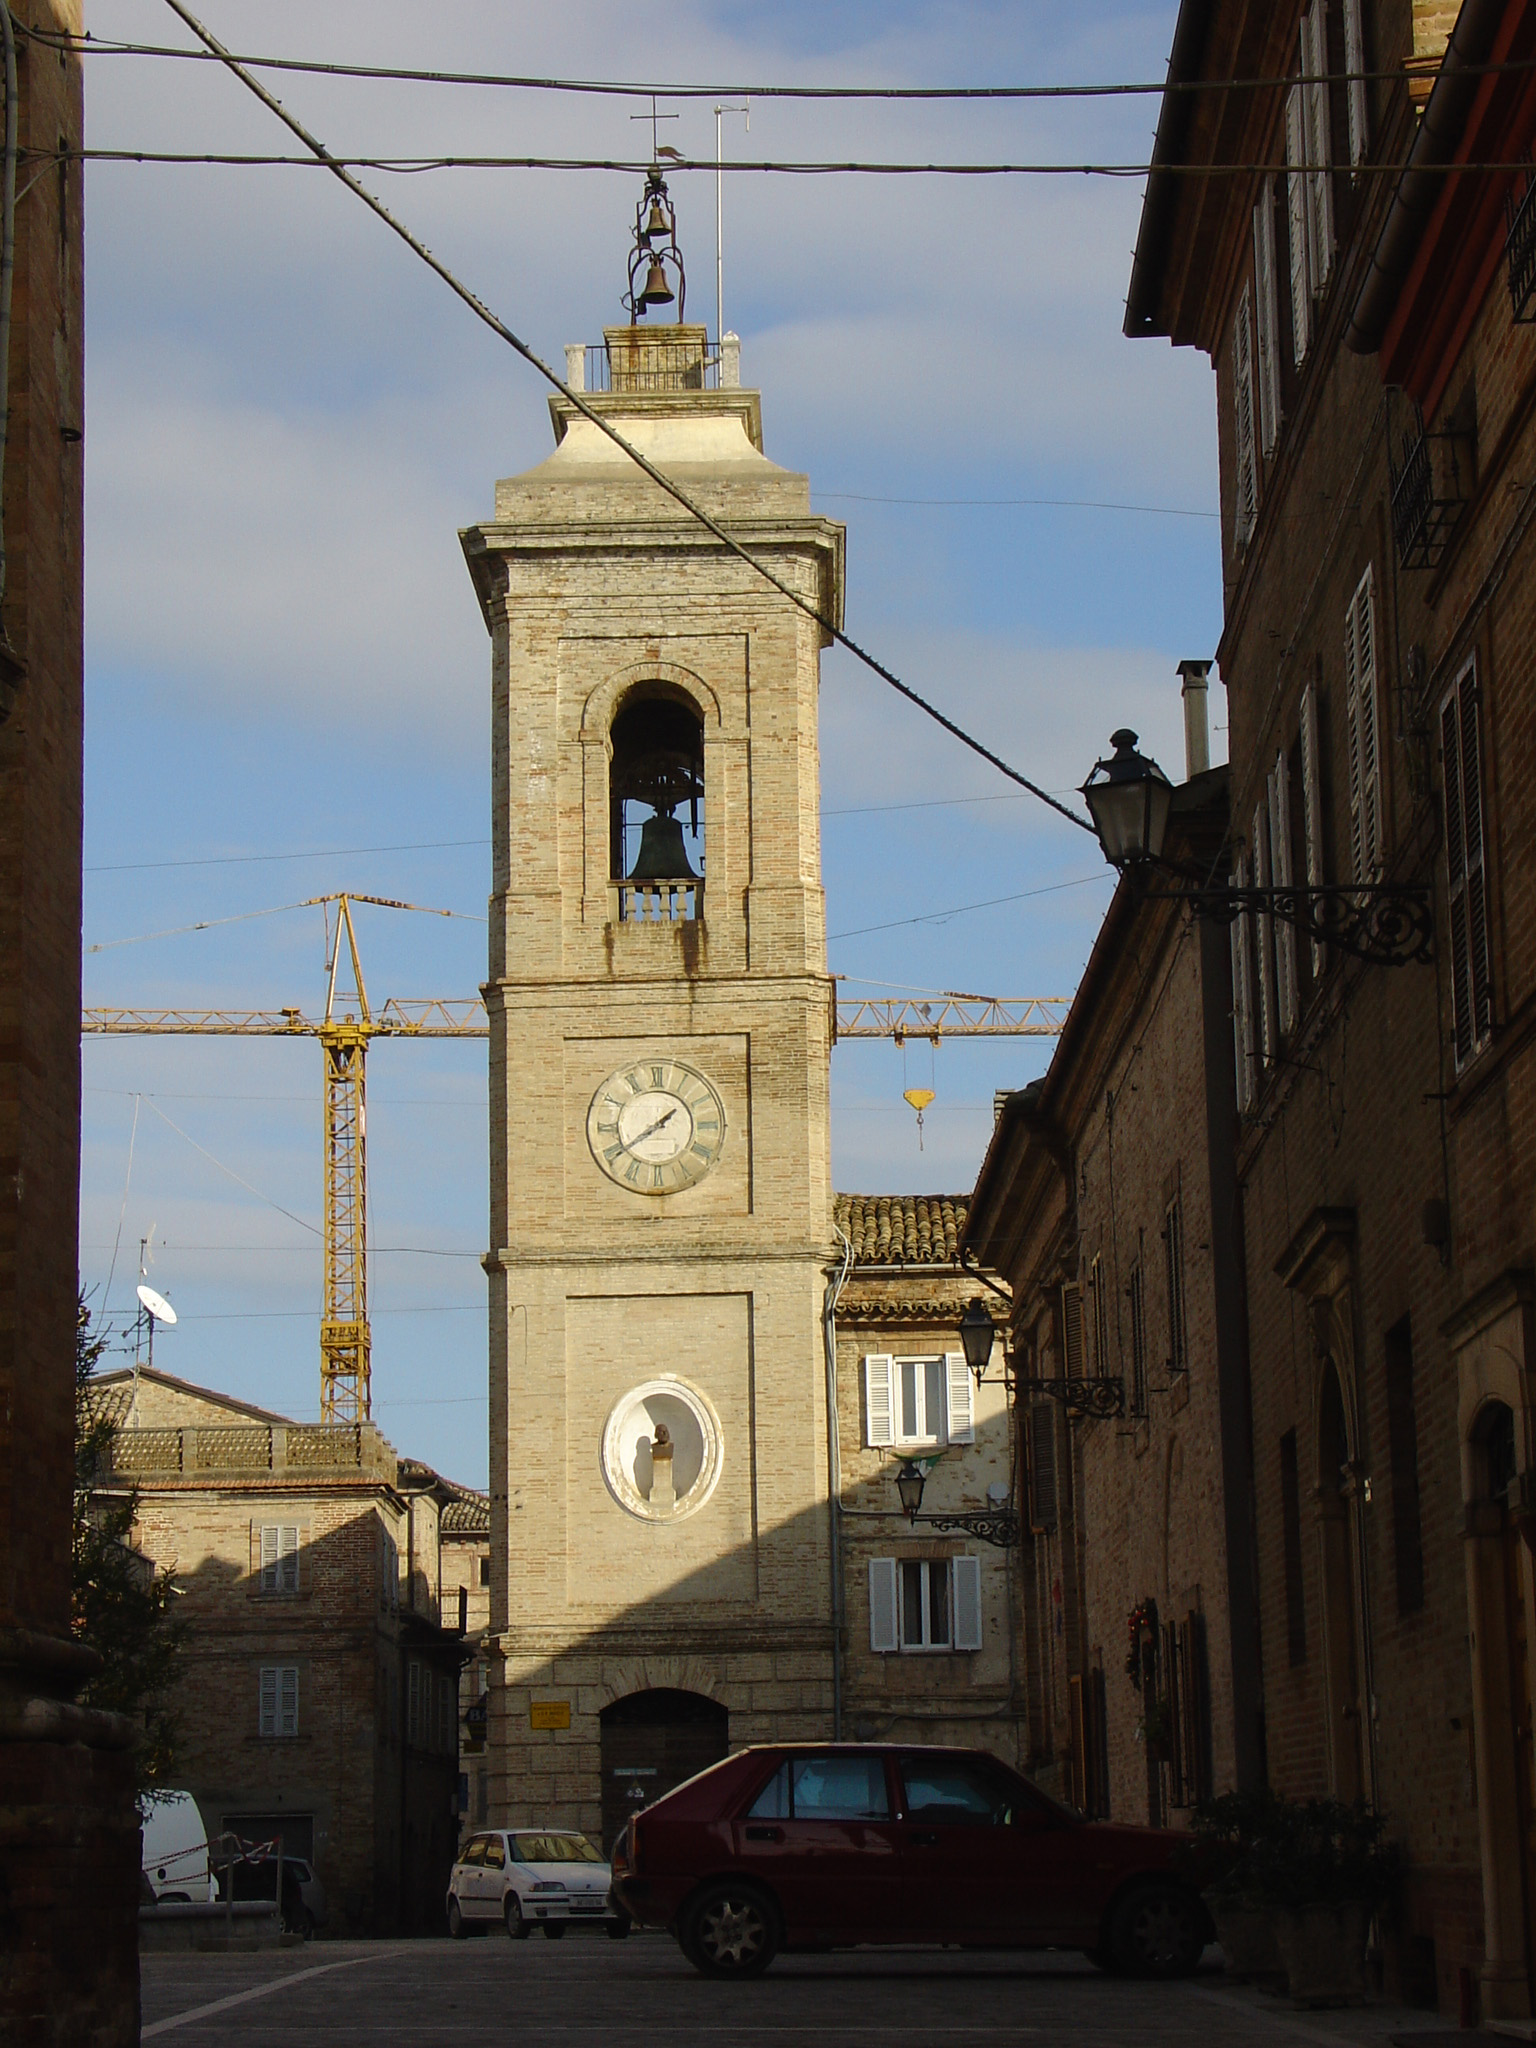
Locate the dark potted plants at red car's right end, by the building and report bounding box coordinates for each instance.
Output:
[1194,1792,1399,2005]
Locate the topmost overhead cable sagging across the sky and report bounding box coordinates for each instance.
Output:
[16,18,1536,102]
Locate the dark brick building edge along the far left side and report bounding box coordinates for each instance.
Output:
[0,0,139,2048]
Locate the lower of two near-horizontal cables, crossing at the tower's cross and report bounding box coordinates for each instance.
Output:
[51,146,1530,178]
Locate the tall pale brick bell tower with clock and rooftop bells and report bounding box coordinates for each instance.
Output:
[463,170,844,1845]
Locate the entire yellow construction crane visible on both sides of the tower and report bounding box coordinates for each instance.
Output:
[80,891,1071,1423]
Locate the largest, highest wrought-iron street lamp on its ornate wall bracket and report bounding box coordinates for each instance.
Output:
[1083,727,1434,967]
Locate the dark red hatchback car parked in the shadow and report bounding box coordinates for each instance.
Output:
[612,1743,1212,1976]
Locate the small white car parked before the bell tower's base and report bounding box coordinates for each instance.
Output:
[449,1827,629,1942]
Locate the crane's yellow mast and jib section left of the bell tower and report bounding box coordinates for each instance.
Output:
[80,893,485,1423]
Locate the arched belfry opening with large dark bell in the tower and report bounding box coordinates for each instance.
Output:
[608,684,705,883]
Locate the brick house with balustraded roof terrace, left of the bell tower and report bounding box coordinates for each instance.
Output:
[96,1368,465,1933]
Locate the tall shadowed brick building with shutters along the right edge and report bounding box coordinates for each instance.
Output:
[1126,0,1536,2021]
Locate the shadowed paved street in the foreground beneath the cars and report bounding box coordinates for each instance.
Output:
[143,1935,1466,2048]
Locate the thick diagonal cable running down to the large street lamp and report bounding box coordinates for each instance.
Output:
[156,0,1094,831]
